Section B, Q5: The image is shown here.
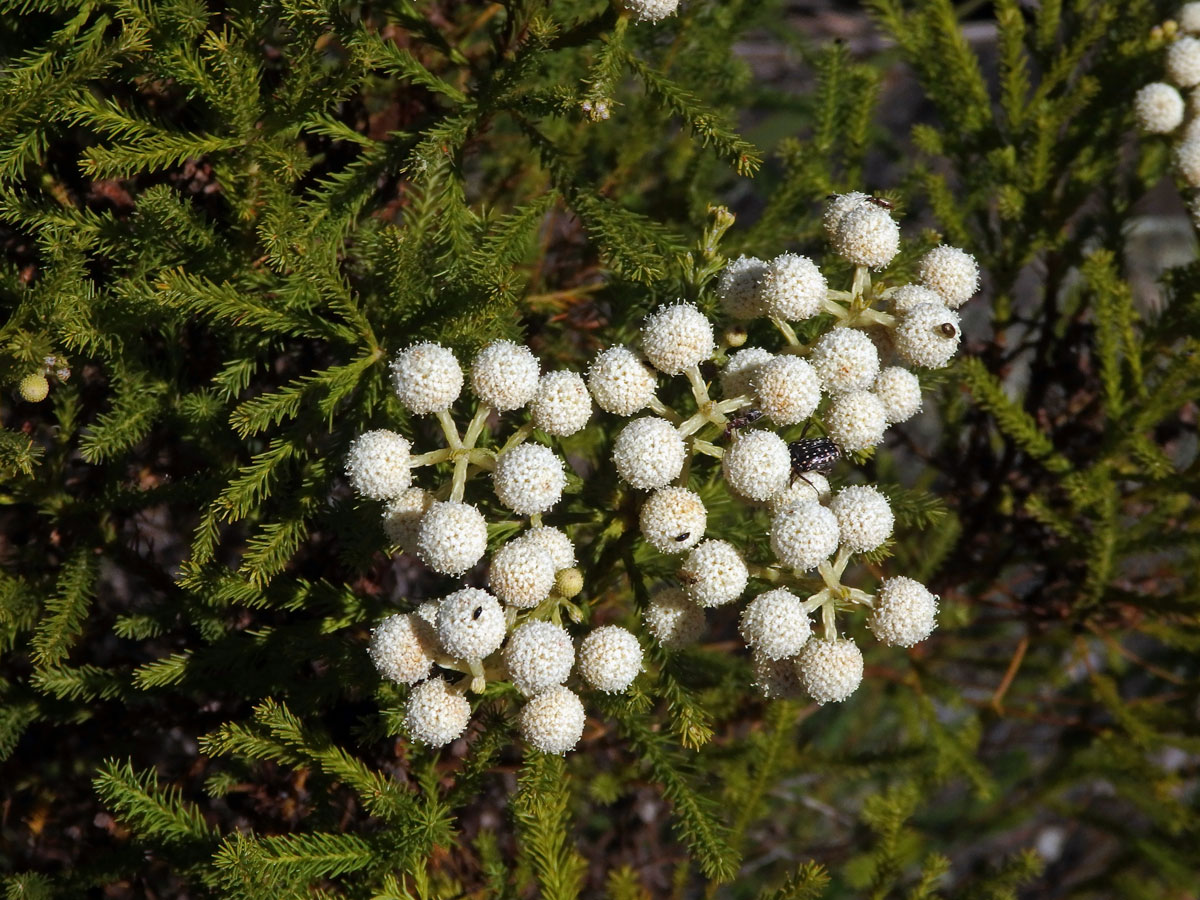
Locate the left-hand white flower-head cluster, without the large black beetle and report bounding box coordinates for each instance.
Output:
[346,338,652,754]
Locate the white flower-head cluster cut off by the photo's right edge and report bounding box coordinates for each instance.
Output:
[1133,2,1200,198]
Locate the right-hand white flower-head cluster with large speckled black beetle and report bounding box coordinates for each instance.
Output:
[578,192,960,703]
